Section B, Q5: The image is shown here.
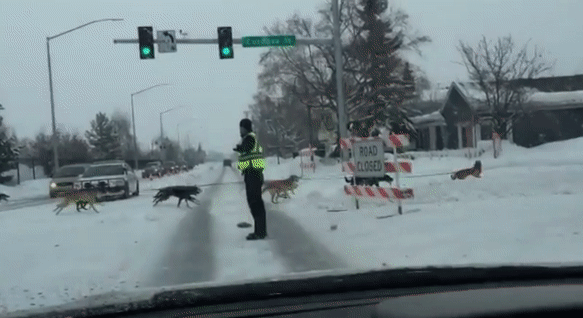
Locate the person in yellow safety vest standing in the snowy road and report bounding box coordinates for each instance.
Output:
[233,118,267,240]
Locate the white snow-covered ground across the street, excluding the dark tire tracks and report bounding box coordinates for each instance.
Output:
[0,138,583,316]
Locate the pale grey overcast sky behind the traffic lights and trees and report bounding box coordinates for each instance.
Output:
[0,0,583,151]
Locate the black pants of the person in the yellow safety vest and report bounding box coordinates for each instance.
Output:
[243,170,267,236]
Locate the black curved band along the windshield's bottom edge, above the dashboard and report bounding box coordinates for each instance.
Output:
[6,262,583,318]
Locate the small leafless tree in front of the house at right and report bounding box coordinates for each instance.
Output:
[458,35,554,138]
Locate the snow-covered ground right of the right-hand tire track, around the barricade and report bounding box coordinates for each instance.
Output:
[267,138,583,269]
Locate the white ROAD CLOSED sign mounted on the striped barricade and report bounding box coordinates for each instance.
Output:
[352,139,385,178]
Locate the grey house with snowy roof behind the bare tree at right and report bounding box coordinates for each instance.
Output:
[411,75,583,150]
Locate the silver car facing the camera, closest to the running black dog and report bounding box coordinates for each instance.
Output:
[74,162,140,198]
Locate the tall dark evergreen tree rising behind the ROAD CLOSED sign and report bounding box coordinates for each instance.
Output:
[350,0,415,134]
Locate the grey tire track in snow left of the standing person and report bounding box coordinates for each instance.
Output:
[147,169,225,287]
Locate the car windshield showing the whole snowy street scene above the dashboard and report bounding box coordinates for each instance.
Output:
[0,0,583,316]
